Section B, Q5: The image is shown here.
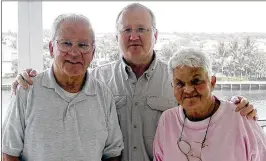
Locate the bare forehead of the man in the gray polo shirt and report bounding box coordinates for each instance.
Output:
[57,21,92,39]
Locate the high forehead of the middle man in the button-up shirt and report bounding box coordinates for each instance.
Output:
[118,7,152,27]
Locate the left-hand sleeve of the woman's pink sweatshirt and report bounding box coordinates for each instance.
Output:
[153,113,165,161]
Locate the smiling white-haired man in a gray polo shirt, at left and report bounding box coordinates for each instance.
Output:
[2,14,123,161]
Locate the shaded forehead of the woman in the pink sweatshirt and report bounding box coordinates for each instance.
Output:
[173,66,207,80]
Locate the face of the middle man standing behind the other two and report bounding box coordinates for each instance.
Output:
[117,8,157,65]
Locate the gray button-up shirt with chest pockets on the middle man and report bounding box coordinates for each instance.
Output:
[91,55,176,161]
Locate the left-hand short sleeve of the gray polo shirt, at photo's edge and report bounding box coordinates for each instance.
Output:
[2,89,26,156]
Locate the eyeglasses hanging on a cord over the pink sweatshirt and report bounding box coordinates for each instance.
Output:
[177,114,211,161]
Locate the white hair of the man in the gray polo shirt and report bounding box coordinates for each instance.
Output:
[51,13,95,43]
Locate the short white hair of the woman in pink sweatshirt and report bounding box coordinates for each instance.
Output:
[168,48,212,81]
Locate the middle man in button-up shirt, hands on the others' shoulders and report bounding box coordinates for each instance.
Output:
[10,3,256,161]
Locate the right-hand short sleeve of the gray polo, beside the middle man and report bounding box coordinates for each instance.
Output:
[103,91,124,159]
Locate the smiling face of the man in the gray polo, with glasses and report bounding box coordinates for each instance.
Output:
[49,21,94,77]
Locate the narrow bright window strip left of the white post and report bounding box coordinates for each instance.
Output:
[1,1,18,122]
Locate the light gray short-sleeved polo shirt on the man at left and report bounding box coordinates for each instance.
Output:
[2,70,123,161]
